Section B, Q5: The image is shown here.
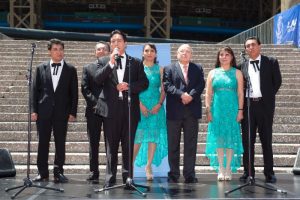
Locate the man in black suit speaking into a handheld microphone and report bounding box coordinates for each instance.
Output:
[95,30,149,187]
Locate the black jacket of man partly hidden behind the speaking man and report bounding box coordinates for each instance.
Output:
[81,60,103,117]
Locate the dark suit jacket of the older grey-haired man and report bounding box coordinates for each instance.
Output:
[163,62,205,120]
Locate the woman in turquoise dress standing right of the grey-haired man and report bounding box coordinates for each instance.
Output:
[205,46,244,181]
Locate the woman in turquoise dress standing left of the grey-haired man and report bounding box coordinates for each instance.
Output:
[133,43,168,181]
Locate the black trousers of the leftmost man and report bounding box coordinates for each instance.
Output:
[36,119,68,177]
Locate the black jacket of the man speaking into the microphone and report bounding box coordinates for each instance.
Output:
[95,54,149,122]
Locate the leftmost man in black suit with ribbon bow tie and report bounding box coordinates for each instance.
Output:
[31,39,78,183]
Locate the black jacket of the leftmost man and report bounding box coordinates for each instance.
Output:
[31,61,78,120]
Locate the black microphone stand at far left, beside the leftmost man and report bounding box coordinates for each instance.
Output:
[5,43,64,199]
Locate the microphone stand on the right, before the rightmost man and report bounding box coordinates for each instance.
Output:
[225,51,287,196]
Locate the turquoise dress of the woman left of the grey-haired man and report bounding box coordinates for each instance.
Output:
[134,64,168,167]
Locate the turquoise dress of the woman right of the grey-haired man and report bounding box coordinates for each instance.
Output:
[205,67,243,172]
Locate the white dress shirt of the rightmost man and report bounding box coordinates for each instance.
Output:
[246,55,262,98]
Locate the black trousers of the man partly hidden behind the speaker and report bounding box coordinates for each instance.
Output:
[86,114,103,173]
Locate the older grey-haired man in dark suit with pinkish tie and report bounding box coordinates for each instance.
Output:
[163,44,205,183]
